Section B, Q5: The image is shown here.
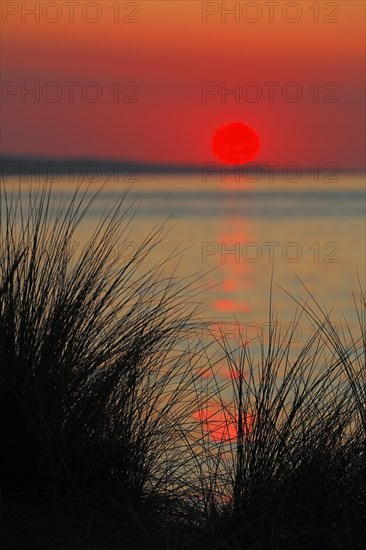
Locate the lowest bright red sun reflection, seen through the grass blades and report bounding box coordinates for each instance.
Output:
[192,404,253,443]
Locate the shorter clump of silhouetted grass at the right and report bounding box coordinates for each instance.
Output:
[187,280,366,550]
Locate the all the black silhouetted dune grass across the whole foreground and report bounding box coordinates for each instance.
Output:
[0,183,366,550]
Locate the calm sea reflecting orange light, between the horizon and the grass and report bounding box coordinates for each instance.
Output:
[1,174,365,358]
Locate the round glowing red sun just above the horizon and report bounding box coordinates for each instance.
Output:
[212,122,260,164]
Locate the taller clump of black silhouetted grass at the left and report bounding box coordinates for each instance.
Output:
[0,181,210,548]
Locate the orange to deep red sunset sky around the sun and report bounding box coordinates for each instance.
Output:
[1,0,365,168]
